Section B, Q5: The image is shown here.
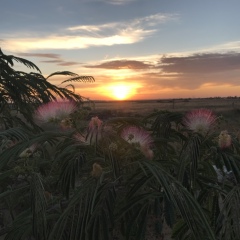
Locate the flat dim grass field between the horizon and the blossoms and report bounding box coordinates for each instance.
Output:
[92,98,240,131]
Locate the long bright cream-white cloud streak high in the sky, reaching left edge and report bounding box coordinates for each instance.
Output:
[3,14,175,51]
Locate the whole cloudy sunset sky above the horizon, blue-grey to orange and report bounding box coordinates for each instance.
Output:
[0,0,240,100]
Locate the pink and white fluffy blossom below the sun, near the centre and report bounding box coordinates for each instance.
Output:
[121,126,153,159]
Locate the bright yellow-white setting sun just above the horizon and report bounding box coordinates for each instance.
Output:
[108,84,136,100]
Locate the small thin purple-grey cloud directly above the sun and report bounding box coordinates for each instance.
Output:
[84,60,151,69]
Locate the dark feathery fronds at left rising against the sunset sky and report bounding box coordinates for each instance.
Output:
[0,49,94,131]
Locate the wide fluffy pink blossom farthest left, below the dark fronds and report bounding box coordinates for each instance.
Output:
[36,102,77,123]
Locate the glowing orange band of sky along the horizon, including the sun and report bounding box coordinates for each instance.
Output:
[75,81,240,101]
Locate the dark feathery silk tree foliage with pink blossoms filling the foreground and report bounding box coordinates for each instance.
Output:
[0,49,240,240]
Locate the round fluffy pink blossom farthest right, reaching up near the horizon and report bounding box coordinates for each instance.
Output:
[183,108,217,133]
